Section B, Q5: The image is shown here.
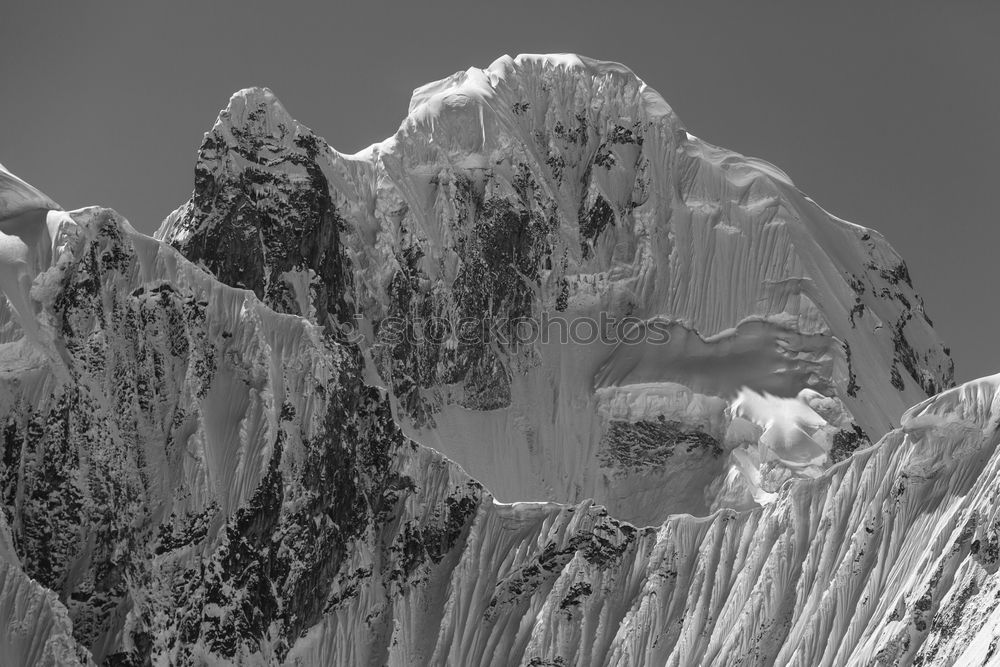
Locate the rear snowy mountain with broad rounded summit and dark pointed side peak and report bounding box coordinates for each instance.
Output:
[158,56,952,523]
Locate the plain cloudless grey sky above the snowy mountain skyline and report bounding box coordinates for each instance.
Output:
[0,0,1000,379]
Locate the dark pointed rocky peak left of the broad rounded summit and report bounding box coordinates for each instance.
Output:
[164,95,352,326]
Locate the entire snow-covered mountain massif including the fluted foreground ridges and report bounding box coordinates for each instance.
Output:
[0,56,984,666]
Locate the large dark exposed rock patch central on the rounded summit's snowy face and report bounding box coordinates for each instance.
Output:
[373,172,557,424]
